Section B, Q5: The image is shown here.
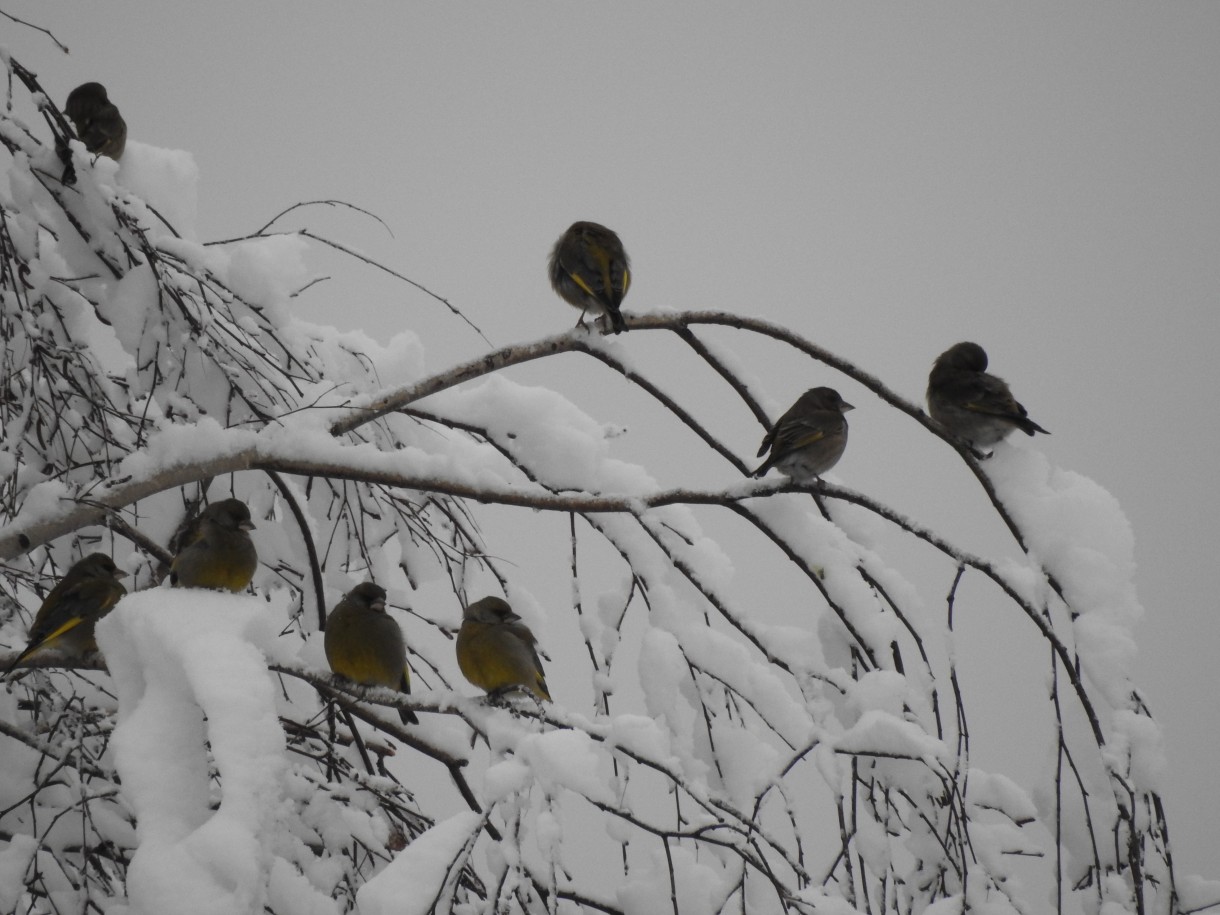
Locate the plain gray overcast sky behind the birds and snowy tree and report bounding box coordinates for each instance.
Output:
[9,0,1220,876]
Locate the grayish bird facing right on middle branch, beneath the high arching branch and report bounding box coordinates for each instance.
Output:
[753,387,855,483]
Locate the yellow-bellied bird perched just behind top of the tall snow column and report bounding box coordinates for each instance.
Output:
[170,499,259,592]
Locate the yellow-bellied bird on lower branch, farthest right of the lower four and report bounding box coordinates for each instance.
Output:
[458,597,550,702]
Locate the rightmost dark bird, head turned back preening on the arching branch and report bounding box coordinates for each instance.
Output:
[927,342,1050,448]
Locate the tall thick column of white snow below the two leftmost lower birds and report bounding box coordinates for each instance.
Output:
[98,588,285,915]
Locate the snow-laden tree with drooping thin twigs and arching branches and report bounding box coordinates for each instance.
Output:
[0,55,1210,915]
